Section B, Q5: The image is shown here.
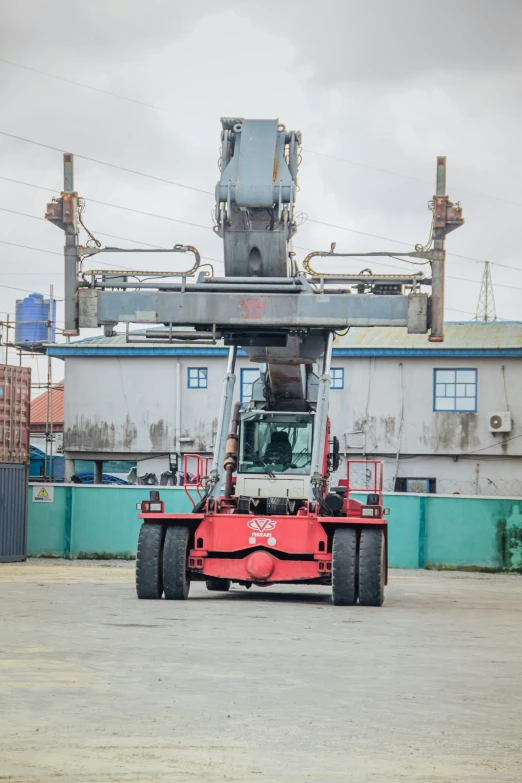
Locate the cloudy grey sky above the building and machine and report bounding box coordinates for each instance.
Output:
[0,0,522,382]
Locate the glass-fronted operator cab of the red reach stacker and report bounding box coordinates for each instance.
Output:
[236,410,315,500]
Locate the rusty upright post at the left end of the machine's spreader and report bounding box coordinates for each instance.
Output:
[62,153,80,336]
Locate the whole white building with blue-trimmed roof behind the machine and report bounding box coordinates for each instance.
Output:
[50,322,522,495]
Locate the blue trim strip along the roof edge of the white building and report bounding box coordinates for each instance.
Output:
[47,343,522,358]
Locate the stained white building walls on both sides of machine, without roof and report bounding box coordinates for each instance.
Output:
[64,355,522,495]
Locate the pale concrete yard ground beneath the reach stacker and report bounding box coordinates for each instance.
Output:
[0,560,522,783]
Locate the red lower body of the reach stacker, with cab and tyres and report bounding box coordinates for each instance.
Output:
[136,398,388,606]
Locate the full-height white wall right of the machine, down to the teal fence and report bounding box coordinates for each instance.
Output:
[330,356,522,495]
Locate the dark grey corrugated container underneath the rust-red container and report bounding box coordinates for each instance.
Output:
[0,463,27,563]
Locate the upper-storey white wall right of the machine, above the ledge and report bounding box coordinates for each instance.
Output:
[331,357,522,456]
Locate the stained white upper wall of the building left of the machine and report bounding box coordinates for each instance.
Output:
[64,356,252,459]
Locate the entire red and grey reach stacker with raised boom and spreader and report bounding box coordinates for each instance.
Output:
[41,117,464,606]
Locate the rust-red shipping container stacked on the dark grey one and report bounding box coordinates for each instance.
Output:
[0,364,31,465]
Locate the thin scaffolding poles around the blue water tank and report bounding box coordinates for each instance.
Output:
[0,285,61,482]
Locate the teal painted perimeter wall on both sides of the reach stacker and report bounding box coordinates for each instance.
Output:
[27,484,522,571]
